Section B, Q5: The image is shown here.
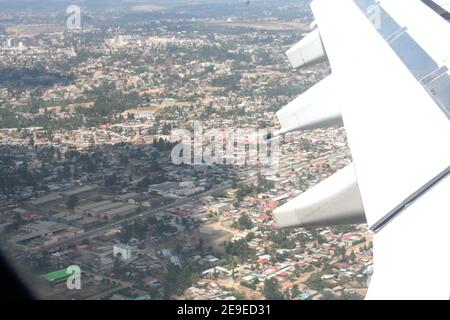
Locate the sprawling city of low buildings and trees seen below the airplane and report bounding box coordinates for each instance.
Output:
[0,0,373,300]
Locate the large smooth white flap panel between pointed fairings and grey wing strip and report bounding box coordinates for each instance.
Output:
[312,0,450,230]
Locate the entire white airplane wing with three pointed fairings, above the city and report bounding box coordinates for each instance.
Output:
[274,0,450,299]
